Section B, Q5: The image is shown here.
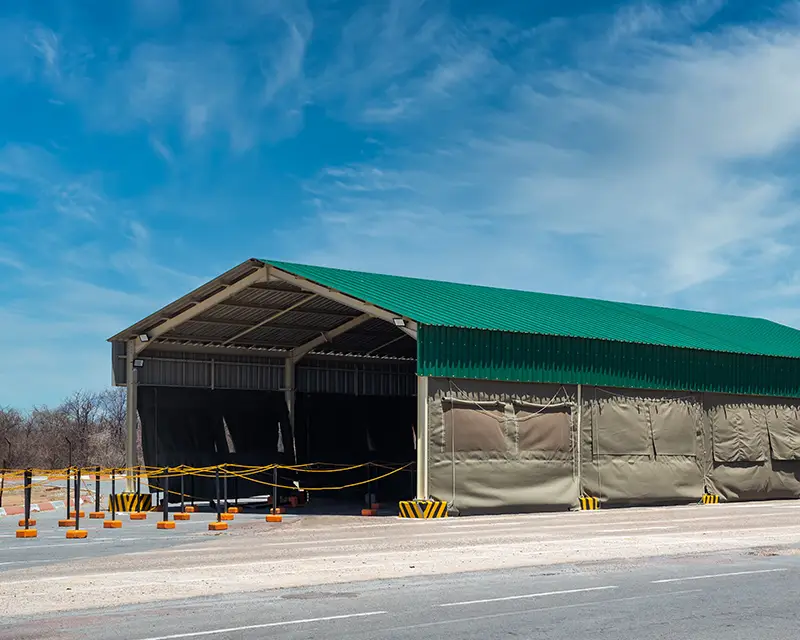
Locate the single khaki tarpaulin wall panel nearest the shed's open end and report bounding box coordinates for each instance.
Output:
[429,379,578,512]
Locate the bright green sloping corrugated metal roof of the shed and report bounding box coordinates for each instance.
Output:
[266,261,800,358]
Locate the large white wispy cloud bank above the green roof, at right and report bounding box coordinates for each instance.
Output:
[296,2,800,313]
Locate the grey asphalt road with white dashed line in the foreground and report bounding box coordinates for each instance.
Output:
[0,549,800,640]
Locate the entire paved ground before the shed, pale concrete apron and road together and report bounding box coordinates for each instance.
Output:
[0,501,800,640]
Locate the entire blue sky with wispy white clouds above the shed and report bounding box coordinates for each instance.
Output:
[0,0,800,407]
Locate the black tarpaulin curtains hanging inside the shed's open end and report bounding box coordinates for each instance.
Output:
[138,387,416,501]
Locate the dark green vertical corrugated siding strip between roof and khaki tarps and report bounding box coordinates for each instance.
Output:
[418,326,800,397]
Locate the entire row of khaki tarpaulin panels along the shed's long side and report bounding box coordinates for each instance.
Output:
[428,379,800,512]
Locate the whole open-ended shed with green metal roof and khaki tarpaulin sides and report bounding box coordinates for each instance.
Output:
[110,259,800,512]
